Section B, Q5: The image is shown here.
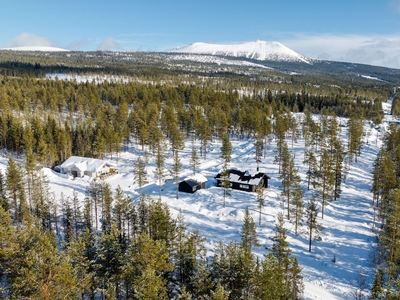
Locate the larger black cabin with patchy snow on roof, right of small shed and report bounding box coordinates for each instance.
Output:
[215,169,271,192]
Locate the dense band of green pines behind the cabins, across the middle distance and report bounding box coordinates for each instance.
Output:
[0,78,383,167]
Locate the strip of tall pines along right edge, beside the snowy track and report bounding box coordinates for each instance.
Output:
[371,124,400,299]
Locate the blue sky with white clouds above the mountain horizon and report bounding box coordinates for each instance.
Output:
[0,0,400,68]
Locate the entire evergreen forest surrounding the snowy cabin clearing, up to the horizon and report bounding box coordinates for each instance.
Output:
[0,51,400,300]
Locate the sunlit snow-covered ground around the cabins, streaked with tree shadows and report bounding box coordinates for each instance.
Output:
[0,112,388,300]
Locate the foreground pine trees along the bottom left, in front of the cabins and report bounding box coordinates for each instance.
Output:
[0,157,303,300]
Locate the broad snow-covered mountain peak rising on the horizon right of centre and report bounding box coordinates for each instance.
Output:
[171,41,311,64]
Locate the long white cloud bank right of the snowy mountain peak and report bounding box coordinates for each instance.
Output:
[281,34,400,69]
